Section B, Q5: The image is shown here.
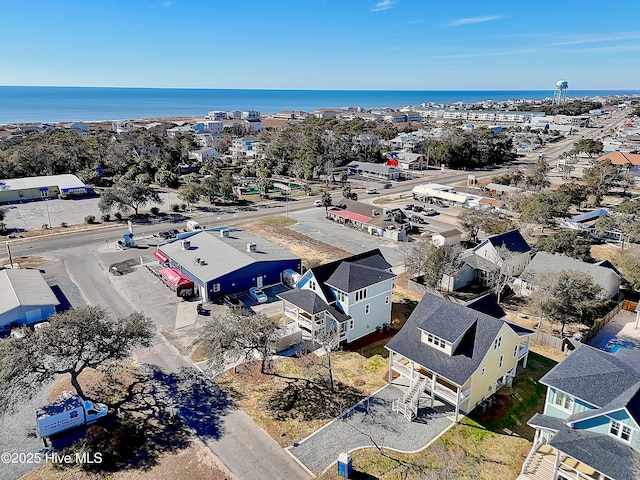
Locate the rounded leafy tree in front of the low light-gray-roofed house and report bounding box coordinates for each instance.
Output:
[545,271,607,334]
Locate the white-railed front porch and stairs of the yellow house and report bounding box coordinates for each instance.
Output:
[389,352,471,422]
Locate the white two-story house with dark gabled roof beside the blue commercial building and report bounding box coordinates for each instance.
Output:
[278,249,396,343]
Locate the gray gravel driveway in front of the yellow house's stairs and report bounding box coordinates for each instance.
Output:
[287,385,454,475]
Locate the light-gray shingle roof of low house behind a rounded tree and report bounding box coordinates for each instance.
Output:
[513,252,620,298]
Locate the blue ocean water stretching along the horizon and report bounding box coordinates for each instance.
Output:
[0,86,640,124]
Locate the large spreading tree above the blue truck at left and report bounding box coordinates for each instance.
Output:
[0,306,155,414]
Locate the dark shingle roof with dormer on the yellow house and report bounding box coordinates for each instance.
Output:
[386,293,528,385]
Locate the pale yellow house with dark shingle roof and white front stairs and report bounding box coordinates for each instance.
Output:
[386,293,533,421]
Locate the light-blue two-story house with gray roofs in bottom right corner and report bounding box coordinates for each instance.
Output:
[519,345,640,480]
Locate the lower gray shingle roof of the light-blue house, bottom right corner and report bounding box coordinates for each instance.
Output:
[549,428,640,480]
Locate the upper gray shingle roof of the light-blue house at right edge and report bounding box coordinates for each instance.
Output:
[540,345,640,408]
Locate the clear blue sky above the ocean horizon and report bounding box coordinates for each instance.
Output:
[0,0,640,90]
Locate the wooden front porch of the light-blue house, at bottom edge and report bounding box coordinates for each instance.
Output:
[521,443,611,480]
